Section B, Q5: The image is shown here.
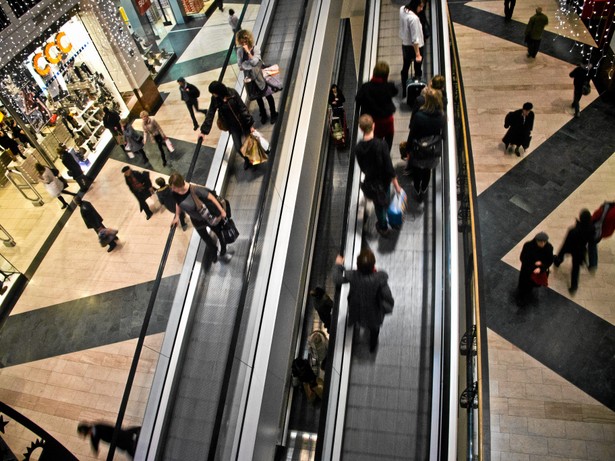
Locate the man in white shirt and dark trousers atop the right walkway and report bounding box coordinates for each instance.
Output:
[399,0,425,98]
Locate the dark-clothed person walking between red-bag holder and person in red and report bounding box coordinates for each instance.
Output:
[553,209,594,294]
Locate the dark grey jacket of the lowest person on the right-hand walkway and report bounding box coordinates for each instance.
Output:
[333,264,395,328]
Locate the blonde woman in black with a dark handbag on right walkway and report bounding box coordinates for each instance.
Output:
[404,87,444,202]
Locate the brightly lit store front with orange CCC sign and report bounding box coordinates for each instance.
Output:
[0,15,128,183]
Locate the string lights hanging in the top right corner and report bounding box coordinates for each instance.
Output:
[555,0,615,79]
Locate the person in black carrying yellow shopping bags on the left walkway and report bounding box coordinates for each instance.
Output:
[199,81,254,170]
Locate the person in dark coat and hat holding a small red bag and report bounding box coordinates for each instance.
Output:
[517,232,553,306]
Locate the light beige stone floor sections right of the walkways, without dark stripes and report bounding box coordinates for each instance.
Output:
[455,0,615,461]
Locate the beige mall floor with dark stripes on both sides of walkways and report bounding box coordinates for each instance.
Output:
[0,0,615,461]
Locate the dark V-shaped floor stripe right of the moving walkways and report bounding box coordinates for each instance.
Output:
[478,96,615,410]
